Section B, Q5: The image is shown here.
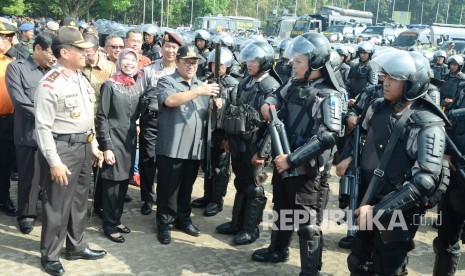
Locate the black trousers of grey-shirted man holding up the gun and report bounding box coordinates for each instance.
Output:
[157,155,202,227]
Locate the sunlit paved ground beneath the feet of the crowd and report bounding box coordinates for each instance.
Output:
[0,167,465,276]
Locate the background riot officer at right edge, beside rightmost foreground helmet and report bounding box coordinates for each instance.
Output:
[440,55,465,108]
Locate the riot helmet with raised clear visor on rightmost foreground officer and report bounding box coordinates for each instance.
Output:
[371,49,430,101]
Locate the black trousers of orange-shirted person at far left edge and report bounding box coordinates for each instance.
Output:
[0,114,15,201]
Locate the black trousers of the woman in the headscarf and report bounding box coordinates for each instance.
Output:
[101,179,129,234]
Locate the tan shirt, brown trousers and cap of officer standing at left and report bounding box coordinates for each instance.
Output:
[34,27,106,274]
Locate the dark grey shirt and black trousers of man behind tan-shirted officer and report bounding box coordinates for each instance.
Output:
[6,56,49,231]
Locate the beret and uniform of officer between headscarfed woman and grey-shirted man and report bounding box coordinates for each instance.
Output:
[139,32,182,215]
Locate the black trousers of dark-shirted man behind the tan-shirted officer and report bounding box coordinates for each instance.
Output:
[16,145,42,220]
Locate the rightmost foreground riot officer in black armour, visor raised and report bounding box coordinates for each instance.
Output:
[338,50,447,275]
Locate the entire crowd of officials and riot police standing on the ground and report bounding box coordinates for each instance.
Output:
[0,14,465,276]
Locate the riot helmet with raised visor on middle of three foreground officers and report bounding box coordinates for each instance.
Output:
[284,32,331,77]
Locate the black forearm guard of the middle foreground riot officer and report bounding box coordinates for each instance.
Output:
[287,131,337,168]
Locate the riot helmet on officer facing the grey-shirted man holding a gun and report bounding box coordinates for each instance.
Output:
[239,41,274,72]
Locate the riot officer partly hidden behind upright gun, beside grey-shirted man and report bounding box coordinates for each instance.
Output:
[191,48,239,217]
